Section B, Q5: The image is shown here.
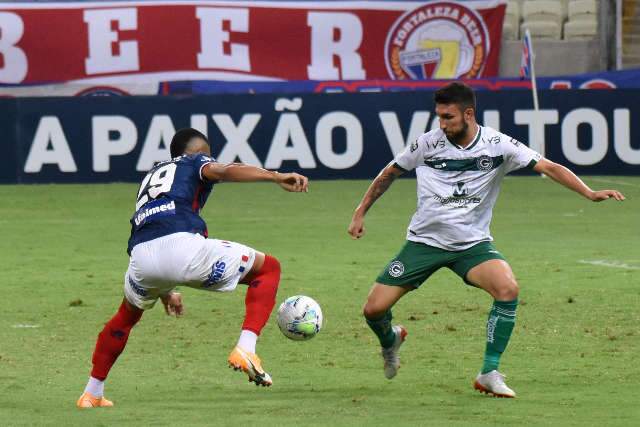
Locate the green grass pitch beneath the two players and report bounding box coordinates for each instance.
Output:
[0,177,640,426]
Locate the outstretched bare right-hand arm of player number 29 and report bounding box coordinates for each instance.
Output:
[202,162,309,193]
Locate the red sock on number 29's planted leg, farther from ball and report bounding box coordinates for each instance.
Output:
[91,301,143,381]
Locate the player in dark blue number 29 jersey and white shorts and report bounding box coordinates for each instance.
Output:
[77,129,308,408]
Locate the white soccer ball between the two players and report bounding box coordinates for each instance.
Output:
[278,295,322,341]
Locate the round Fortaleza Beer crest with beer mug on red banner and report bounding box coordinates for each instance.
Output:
[385,2,490,80]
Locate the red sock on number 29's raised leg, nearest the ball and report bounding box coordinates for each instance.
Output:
[242,255,280,335]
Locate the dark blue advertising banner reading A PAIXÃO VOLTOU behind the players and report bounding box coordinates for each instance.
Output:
[0,90,640,183]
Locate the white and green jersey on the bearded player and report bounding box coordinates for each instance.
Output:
[395,126,542,251]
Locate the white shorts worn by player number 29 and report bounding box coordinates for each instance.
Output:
[124,233,256,310]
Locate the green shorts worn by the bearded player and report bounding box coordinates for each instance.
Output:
[376,240,505,288]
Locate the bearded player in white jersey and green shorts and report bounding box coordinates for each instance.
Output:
[348,83,624,397]
